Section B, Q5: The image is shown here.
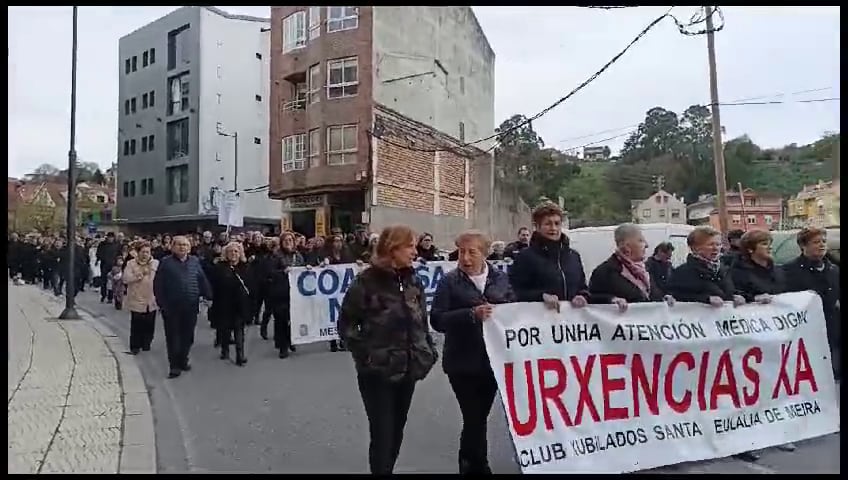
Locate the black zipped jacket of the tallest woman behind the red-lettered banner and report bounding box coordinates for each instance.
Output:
[509,232,589,302]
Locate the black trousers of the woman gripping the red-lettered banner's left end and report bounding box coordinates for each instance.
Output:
[448,374,498,474]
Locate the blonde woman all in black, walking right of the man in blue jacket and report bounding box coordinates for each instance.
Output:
[209,242,253,366]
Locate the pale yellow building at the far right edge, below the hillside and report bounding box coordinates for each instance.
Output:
[786,180,840,228]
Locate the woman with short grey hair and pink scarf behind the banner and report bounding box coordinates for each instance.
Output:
[589,223,674,312]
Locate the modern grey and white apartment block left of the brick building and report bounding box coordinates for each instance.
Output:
[117,6,280,230]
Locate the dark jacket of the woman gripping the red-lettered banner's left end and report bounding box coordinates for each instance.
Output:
[430,265,515,375]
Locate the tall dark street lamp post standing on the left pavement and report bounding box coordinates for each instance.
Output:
[59,6,80,320]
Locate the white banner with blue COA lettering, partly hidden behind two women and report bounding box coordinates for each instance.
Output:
[289,262,508,345]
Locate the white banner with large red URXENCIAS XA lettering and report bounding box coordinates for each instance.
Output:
[483,292,839,473]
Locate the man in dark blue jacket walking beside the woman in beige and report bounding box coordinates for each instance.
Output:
[153,236,212,378]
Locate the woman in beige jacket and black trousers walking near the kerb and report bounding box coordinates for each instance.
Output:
[123,241,159,355]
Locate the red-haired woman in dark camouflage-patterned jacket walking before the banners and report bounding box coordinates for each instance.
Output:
[338,226,438,474]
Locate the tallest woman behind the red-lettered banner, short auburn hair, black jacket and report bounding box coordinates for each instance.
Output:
[509,202,589,311]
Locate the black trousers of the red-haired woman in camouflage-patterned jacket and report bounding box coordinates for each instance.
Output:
[357,374,415,475]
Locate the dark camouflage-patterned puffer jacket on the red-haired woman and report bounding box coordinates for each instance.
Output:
[338,266,438,381]
